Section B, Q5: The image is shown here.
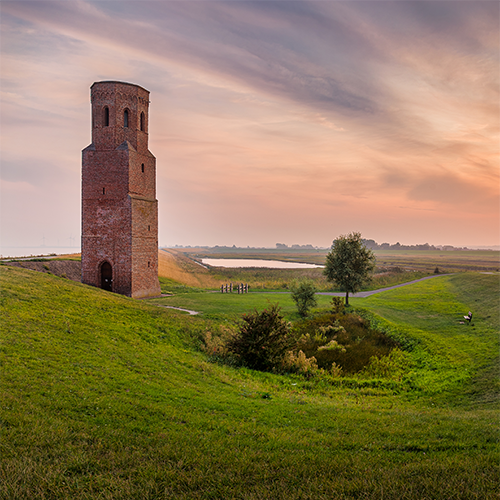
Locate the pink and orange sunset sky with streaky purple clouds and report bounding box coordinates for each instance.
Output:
[0,0,500,250]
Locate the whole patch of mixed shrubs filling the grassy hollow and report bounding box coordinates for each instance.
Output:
[203,297,406,379]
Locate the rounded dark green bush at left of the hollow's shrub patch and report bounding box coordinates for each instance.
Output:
[227,304,293,371]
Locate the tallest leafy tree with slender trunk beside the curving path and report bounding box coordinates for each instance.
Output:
[323,233,375,306]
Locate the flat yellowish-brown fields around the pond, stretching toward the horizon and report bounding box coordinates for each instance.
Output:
[159,248,500,291]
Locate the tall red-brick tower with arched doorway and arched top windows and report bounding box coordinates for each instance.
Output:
[82,81,160,298]
